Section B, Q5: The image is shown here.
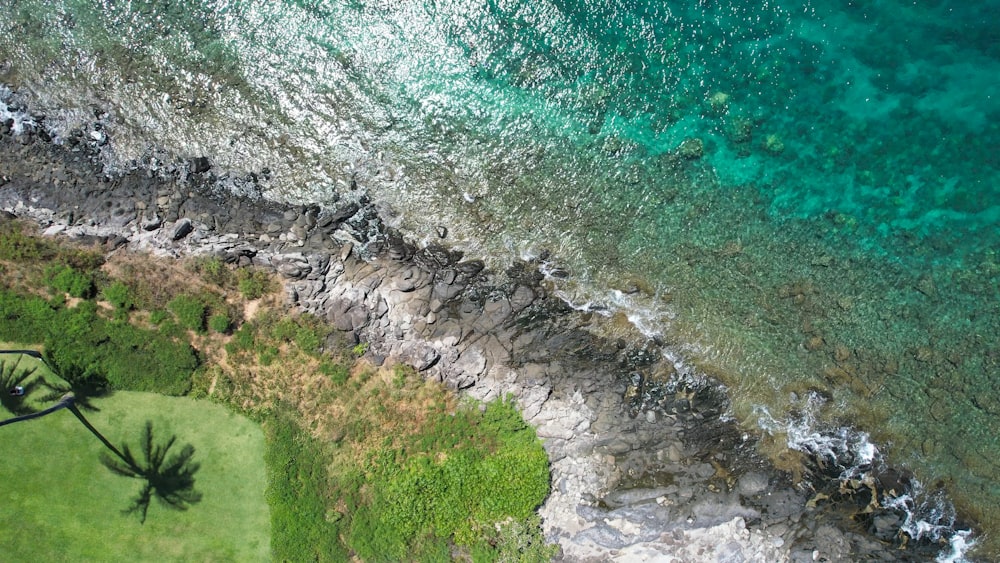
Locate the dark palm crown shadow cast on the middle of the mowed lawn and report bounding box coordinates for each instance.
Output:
[101,421,201,523]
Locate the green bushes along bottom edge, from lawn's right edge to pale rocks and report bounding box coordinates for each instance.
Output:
[265,401,553,562]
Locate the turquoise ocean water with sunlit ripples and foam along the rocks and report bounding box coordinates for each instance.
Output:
[0,0,1000,553]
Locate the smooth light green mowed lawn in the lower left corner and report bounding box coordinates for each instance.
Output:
[0,390,270,561]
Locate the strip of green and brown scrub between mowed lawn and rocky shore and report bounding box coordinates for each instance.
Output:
[0,221,553,561]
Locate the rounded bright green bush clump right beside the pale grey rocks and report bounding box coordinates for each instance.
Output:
[348,401,551,561]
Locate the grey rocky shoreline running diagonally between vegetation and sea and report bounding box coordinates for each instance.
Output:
[0,106,942,562]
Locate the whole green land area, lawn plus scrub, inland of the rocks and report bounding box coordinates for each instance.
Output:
[0,218,552,561]
